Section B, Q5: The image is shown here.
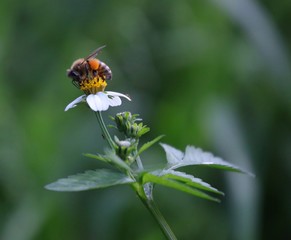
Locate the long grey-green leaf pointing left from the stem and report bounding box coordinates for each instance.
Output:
[45,169,134,192]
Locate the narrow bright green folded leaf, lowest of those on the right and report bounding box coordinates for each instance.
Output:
[142,173,219,202]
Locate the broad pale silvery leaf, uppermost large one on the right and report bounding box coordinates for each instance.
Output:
[161,144,254,176]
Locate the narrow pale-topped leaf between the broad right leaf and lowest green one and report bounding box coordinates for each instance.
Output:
[153,170,224,195]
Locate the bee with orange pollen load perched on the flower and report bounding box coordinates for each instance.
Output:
[67,46,112,88]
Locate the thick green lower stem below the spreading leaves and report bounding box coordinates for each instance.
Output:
[134,184,177,240]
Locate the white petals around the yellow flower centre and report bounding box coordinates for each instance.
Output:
[65,91,131,112]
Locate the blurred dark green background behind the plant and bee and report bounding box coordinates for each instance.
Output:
[0,0,291,240]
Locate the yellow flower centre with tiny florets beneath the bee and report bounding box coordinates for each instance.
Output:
[80,76,107,95]
